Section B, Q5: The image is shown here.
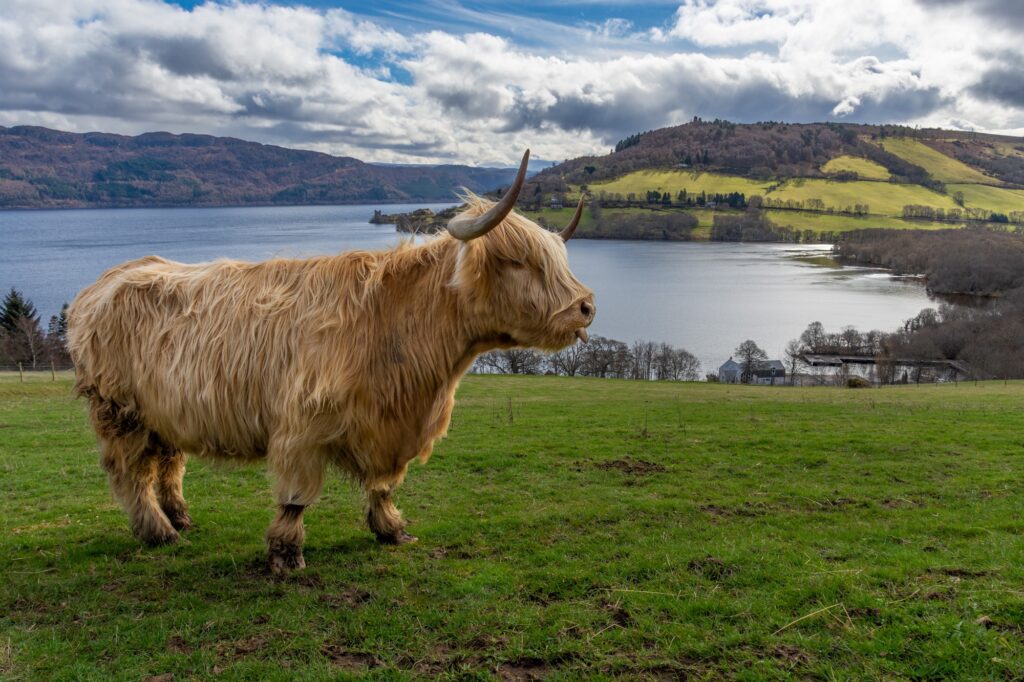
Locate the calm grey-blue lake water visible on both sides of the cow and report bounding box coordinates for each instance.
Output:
[0,204,933,371]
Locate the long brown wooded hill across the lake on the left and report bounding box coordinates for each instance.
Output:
[0,126,515,208]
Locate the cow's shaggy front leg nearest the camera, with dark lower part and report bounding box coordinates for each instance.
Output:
[266,449,325,576]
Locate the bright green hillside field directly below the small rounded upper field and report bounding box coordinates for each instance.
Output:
[766,178,956,216]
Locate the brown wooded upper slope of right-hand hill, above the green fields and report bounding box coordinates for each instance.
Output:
[530,119,1024,193]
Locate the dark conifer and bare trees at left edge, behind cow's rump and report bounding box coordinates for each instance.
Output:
[0,289,71,370]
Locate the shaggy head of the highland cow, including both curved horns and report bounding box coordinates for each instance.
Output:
[449,152,597,350]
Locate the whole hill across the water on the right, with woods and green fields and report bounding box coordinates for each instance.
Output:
[521,119,1024,241]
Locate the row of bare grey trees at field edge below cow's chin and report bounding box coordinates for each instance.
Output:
[471,336,700,381]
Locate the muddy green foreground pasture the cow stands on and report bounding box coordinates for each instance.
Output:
[0,377,1024,680]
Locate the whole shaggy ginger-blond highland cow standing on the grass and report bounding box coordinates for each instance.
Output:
[68,152,595,573]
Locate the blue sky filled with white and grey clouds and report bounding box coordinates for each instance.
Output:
[0,0,1024,165]
